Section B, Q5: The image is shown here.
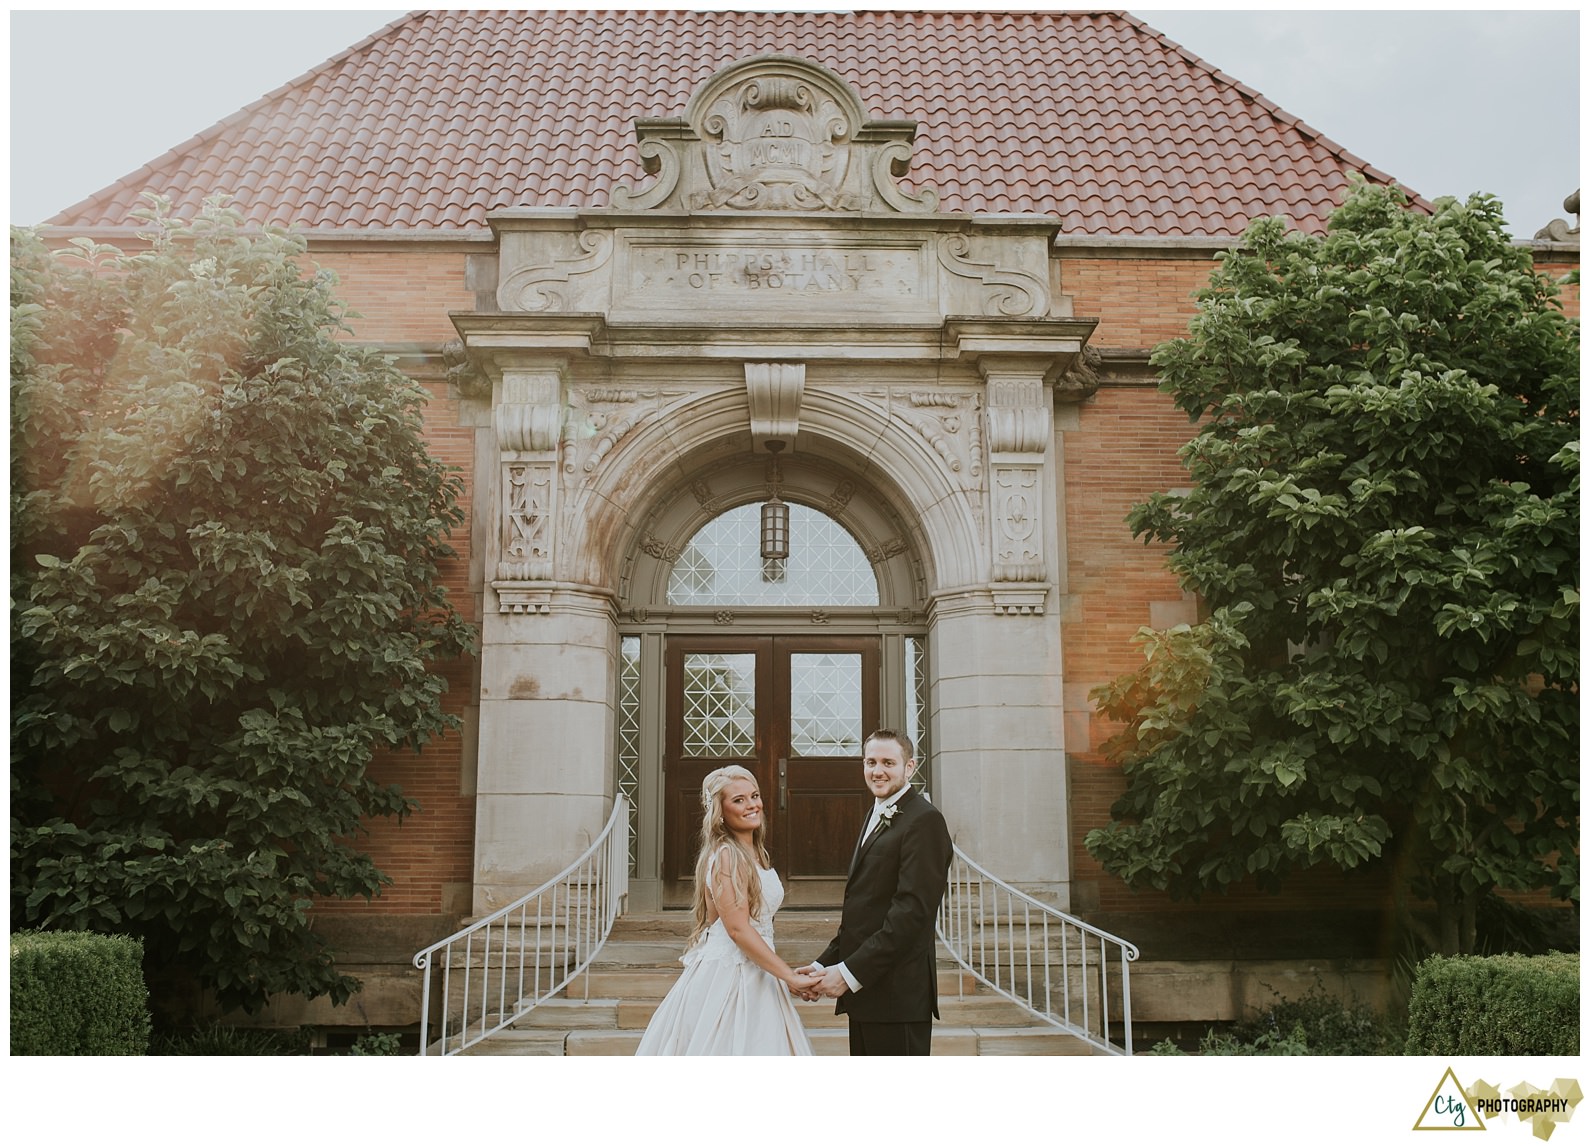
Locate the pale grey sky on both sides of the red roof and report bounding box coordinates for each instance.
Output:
[6,3,1580,238]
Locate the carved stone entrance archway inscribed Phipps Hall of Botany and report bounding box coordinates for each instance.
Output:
[453,57,1094,911]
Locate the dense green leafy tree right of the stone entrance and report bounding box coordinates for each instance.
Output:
[1086,186,1579,952]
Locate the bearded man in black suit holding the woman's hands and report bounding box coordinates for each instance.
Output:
[800,728,951,1055]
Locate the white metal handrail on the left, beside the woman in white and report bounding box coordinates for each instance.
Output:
[413,796,630,1054]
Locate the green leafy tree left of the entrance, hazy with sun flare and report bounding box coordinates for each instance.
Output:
[11,200,472,1008]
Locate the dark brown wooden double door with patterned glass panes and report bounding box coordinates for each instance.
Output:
[663,636,879,906]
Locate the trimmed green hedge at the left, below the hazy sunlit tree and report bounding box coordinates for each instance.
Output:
[11,931,149,1054]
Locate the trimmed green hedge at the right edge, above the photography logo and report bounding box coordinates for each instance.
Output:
[1407,952,1579,1055]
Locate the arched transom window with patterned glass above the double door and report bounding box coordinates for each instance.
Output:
[668,504,878,606]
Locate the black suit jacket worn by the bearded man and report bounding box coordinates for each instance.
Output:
[817,788,951,1022]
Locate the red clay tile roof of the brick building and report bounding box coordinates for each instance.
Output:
[51,11,1418,237]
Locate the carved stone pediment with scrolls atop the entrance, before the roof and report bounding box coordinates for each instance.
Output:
[614,56,937,213]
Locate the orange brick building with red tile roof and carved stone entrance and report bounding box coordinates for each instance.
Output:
[51,11,1577,1022]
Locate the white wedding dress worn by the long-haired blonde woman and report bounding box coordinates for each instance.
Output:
[634,851,811,1055]
